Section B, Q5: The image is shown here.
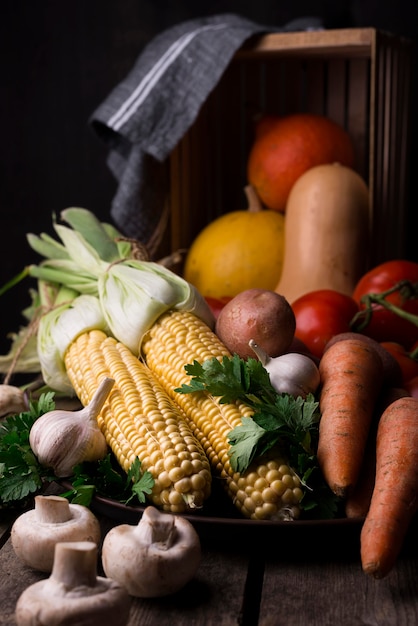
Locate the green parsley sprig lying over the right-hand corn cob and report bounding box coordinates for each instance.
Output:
[176,354,339,519]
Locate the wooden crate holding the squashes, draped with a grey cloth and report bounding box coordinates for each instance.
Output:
[168,28,411,264]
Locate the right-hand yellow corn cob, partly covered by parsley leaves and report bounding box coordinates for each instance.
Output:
[142,311,303,520]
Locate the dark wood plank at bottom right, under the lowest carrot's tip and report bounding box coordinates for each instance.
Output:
[259,557,418,626]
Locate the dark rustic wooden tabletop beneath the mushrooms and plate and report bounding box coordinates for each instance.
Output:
[0,498,418,626]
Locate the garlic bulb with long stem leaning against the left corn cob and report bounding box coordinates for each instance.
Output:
[29,378,115,477]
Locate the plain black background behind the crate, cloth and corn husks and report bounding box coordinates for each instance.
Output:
[0,0,418,352]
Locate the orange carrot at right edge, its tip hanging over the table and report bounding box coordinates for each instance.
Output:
[360,397,418,578]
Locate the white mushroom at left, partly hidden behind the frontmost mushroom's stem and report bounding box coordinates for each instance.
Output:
[11,495,101,573]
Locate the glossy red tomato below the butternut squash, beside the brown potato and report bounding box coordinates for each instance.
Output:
[292,289,358,358]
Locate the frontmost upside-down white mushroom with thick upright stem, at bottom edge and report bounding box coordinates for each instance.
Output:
[15,541,131,626]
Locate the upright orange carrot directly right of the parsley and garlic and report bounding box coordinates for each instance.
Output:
[317,338,383,497]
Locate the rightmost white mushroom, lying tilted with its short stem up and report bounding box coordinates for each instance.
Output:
[102,506,201,598]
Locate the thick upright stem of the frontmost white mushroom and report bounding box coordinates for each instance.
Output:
[51,541,97,590]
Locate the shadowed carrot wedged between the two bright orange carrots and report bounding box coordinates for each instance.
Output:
[345,387,409,519]
